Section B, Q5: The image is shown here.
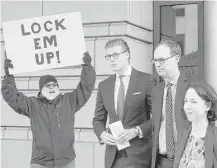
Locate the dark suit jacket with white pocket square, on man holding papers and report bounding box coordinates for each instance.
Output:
[93,68,152,168]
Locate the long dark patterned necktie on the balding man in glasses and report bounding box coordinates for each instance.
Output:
[165,83,175,158]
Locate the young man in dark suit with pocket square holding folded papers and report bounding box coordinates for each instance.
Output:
[93,39,152,168]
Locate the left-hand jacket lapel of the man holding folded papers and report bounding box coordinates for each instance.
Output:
[105,75,119,121]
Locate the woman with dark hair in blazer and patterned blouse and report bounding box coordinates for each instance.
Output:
[173,80,217,168]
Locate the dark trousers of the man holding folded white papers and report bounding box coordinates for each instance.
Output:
[111,150,142,168]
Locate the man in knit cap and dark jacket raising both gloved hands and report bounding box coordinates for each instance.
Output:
[2,52,96,168]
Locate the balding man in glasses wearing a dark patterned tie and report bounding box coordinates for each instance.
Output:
[152,40,193,168]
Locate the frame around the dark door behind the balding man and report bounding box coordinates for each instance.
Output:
[153,1,204,79]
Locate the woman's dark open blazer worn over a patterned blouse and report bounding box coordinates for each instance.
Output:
[173,123,217,168]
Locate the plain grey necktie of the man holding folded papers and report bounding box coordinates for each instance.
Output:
[117,76,125,120]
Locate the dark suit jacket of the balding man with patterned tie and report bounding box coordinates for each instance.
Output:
[152,72,190,168]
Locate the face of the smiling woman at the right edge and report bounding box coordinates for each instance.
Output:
[184,88,209,122]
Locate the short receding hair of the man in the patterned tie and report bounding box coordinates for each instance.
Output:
[155,40,182,57]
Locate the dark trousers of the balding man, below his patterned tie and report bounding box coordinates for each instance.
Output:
[156,154,173,168]
